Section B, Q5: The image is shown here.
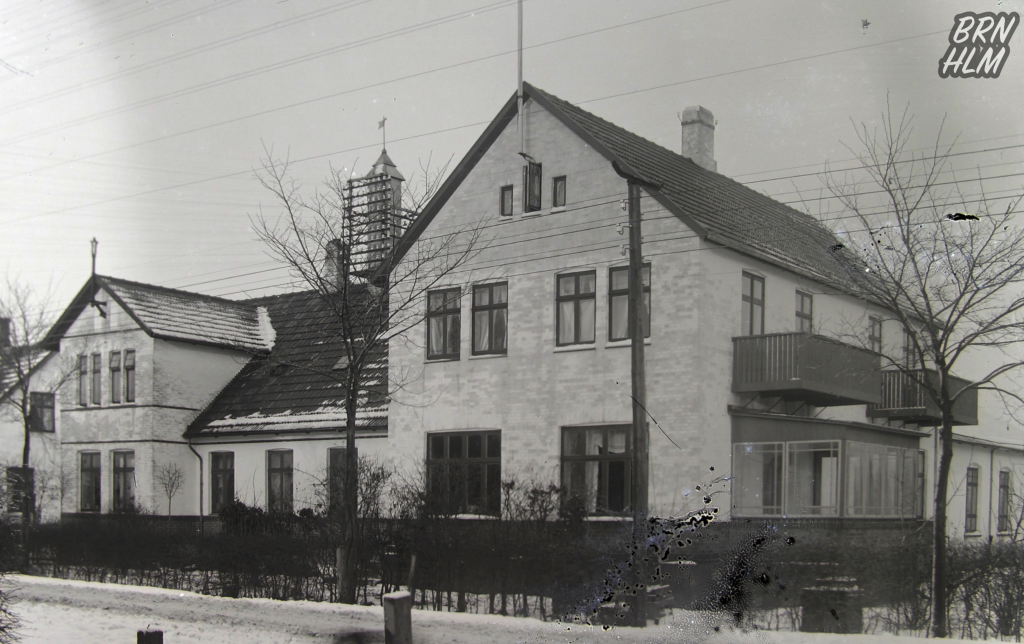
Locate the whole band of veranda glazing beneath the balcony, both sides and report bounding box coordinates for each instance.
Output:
[732,440,924,518]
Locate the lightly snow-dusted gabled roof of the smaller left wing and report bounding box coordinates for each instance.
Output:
[43,275,270,353]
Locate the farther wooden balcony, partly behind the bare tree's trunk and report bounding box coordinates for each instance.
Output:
[867,369,978,425]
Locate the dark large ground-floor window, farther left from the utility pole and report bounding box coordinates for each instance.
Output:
[427,431,502,514]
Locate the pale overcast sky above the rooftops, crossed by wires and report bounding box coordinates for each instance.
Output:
[0,0,1024,307]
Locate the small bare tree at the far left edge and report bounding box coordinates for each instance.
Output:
[0,275,76,536]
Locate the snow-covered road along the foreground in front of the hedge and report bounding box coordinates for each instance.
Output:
[0,575,991,644]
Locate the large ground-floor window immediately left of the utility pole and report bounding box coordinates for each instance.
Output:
[562,425,631,514]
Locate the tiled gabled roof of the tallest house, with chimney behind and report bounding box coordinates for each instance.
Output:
[376,83,847,283]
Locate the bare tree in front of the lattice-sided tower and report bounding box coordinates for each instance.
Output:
[253,151,480,603]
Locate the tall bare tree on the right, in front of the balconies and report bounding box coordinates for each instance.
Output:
[824,102,1024,637]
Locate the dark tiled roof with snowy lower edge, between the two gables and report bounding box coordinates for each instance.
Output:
[185,291,387,437]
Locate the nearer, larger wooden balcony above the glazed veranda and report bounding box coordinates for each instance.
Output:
[732,333,882,406]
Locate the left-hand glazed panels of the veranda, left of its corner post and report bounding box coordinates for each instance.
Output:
[732,440,839,516]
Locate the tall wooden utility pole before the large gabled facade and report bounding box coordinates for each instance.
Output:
[612,163,655,627]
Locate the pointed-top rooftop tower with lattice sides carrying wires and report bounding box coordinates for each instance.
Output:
[343,149,413,276]
